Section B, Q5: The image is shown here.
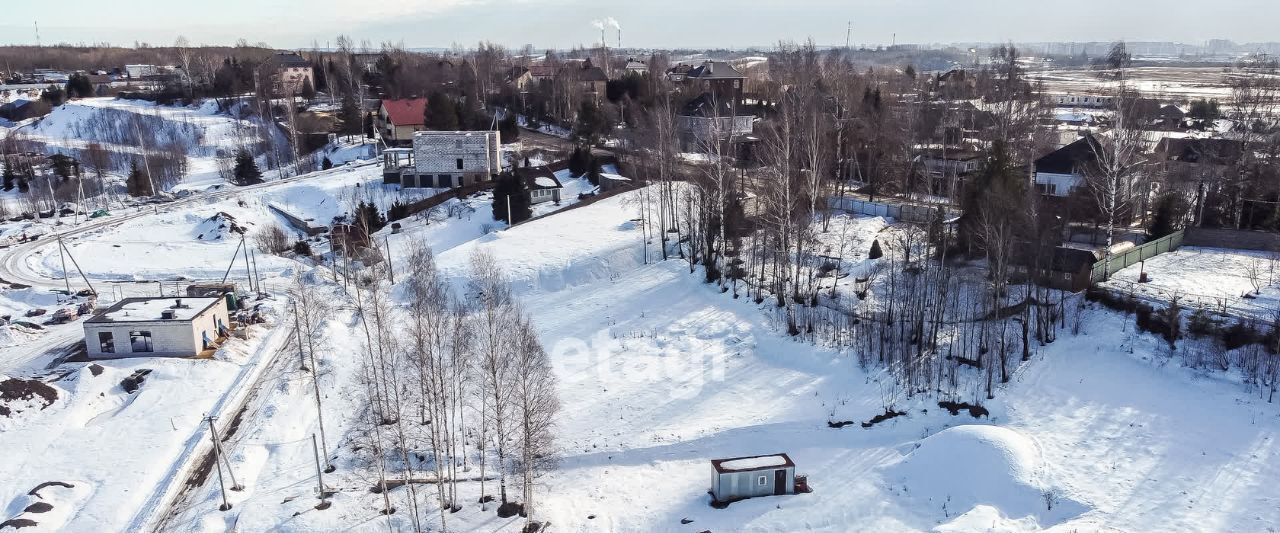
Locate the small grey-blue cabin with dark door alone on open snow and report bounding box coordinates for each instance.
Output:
[712,454,796,504]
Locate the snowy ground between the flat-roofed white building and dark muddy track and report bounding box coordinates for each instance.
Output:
[0,299,287,532]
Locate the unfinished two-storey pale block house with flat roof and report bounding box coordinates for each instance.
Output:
[383,131,502,188]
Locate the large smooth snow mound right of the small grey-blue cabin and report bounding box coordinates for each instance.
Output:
[888,425,1085,530]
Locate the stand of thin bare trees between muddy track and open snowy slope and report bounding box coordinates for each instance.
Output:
[317,241,559,530]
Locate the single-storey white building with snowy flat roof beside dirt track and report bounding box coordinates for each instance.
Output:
[84,297,232,359]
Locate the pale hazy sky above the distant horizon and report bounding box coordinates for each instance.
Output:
[0,0,1280,49]
